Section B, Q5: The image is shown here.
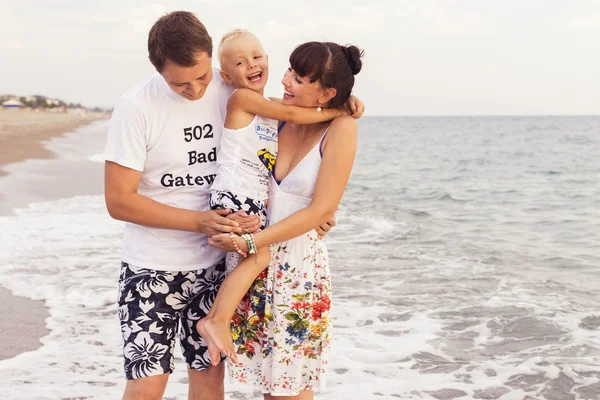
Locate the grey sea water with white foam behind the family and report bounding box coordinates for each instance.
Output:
[0,117,600,400]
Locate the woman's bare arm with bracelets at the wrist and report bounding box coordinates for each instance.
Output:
[210,116,358,251]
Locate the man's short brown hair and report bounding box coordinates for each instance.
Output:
[148,11,212,72]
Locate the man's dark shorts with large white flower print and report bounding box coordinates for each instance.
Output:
[119,260,225,379]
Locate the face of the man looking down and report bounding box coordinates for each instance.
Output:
[161,52,212,100]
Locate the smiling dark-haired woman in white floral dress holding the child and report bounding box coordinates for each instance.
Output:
[210,42,363,400]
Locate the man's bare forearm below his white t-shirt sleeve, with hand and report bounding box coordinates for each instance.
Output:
[104,161,242,236]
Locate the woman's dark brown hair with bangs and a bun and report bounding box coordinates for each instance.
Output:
[290,42,365,108]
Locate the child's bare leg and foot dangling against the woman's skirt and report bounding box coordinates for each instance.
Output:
[196,248,271,365]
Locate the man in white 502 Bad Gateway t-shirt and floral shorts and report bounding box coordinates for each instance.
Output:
[105,11,340,400]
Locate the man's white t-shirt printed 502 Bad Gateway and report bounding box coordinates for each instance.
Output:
[104,69,233,271]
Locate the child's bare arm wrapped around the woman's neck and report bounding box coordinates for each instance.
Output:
[227,88,350,124]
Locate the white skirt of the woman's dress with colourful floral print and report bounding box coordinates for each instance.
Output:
[228,231,331,396]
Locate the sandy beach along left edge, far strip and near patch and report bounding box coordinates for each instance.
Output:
[0,109,108,360]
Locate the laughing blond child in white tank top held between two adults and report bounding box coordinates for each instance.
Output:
[197,30,356,365]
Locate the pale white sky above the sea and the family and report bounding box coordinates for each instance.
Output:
[0,0,600,115]
